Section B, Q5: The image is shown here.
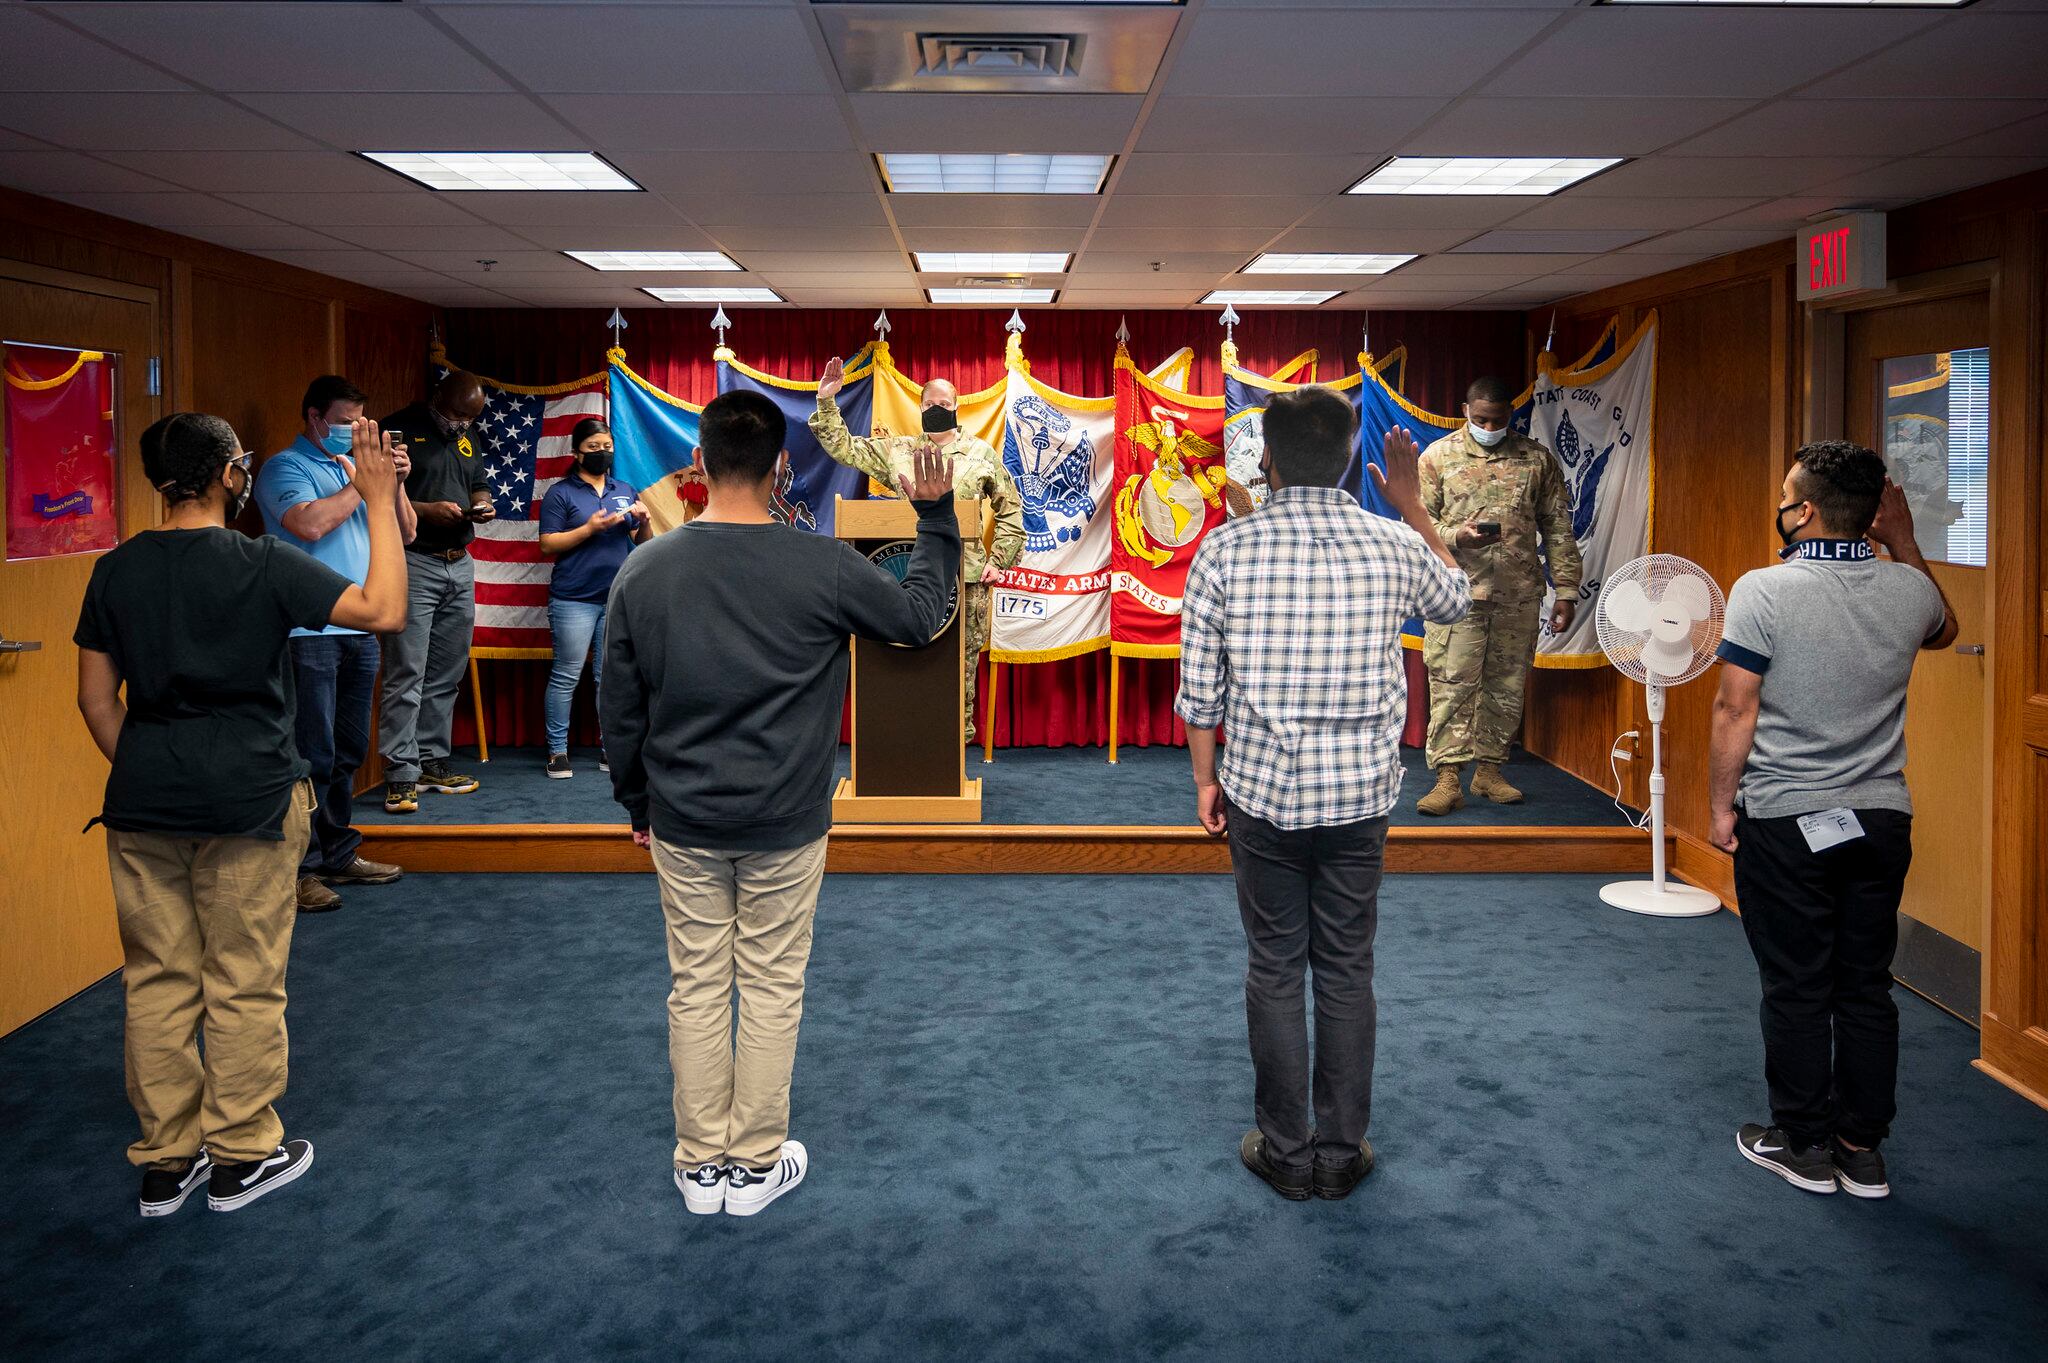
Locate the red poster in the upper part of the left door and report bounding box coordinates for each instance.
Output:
[0,346,117,559]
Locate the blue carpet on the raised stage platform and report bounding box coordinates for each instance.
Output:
[385,747,1624,827]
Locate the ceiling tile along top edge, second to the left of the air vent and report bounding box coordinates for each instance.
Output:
[49,4,504,94]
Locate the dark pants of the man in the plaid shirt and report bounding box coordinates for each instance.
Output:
[1227,804,1386,1169]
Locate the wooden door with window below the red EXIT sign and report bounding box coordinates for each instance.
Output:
[1843,293,1991,1021]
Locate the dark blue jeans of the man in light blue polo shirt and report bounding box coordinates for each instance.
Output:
[291,634,379,876]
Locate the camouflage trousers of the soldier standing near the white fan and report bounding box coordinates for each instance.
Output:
[1421,602,1542,767]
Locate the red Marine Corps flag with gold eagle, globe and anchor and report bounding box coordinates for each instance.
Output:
[1110,350,1229,657]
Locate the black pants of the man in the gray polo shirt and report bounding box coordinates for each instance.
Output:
[1735,808,1913,1146]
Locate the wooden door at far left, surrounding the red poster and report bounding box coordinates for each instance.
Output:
[0,262,162,1034]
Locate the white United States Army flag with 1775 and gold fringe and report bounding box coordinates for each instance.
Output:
[983,366,1116,663]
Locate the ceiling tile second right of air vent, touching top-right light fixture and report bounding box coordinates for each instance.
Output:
[1487,4,1942,98]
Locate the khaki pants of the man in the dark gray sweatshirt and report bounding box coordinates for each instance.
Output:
[653,837,825,1169]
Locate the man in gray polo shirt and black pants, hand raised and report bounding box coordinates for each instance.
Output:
[1710,440,1956,1197]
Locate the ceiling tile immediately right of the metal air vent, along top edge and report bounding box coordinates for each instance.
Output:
[1165,8,1554,96]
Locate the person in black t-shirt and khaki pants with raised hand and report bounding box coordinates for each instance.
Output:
[74,411,406,1216]
